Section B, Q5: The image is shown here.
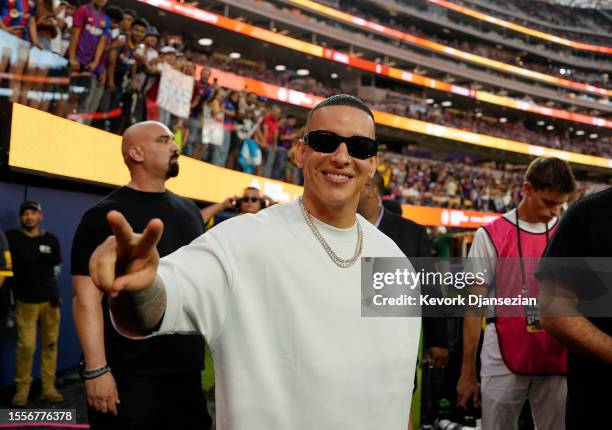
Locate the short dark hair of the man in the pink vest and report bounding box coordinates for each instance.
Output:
[525,157,576,194]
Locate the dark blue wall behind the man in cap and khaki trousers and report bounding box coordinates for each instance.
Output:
[0,182,101,386]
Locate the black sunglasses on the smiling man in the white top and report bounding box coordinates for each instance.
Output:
[304,130,378,160]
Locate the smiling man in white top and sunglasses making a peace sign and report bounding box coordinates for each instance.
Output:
[90,95,421,430]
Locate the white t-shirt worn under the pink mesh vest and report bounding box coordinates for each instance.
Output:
[468,209,557,376]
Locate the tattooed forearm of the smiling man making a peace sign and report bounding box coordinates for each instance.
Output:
[109,277,166,333]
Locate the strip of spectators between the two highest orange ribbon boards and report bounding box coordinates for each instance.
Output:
[296,1,606,87]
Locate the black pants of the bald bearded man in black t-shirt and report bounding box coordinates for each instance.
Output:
[88,372,212,430]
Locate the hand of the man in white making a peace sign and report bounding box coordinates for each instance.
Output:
[89,211,164,297]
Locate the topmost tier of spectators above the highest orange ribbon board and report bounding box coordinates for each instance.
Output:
[457,0,612,46]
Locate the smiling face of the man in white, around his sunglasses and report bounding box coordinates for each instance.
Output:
[296,106,378,208]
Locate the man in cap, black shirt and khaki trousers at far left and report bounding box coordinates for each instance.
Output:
[6,201,64,406]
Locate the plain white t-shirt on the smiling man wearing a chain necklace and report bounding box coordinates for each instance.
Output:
[158,202,421,430]
